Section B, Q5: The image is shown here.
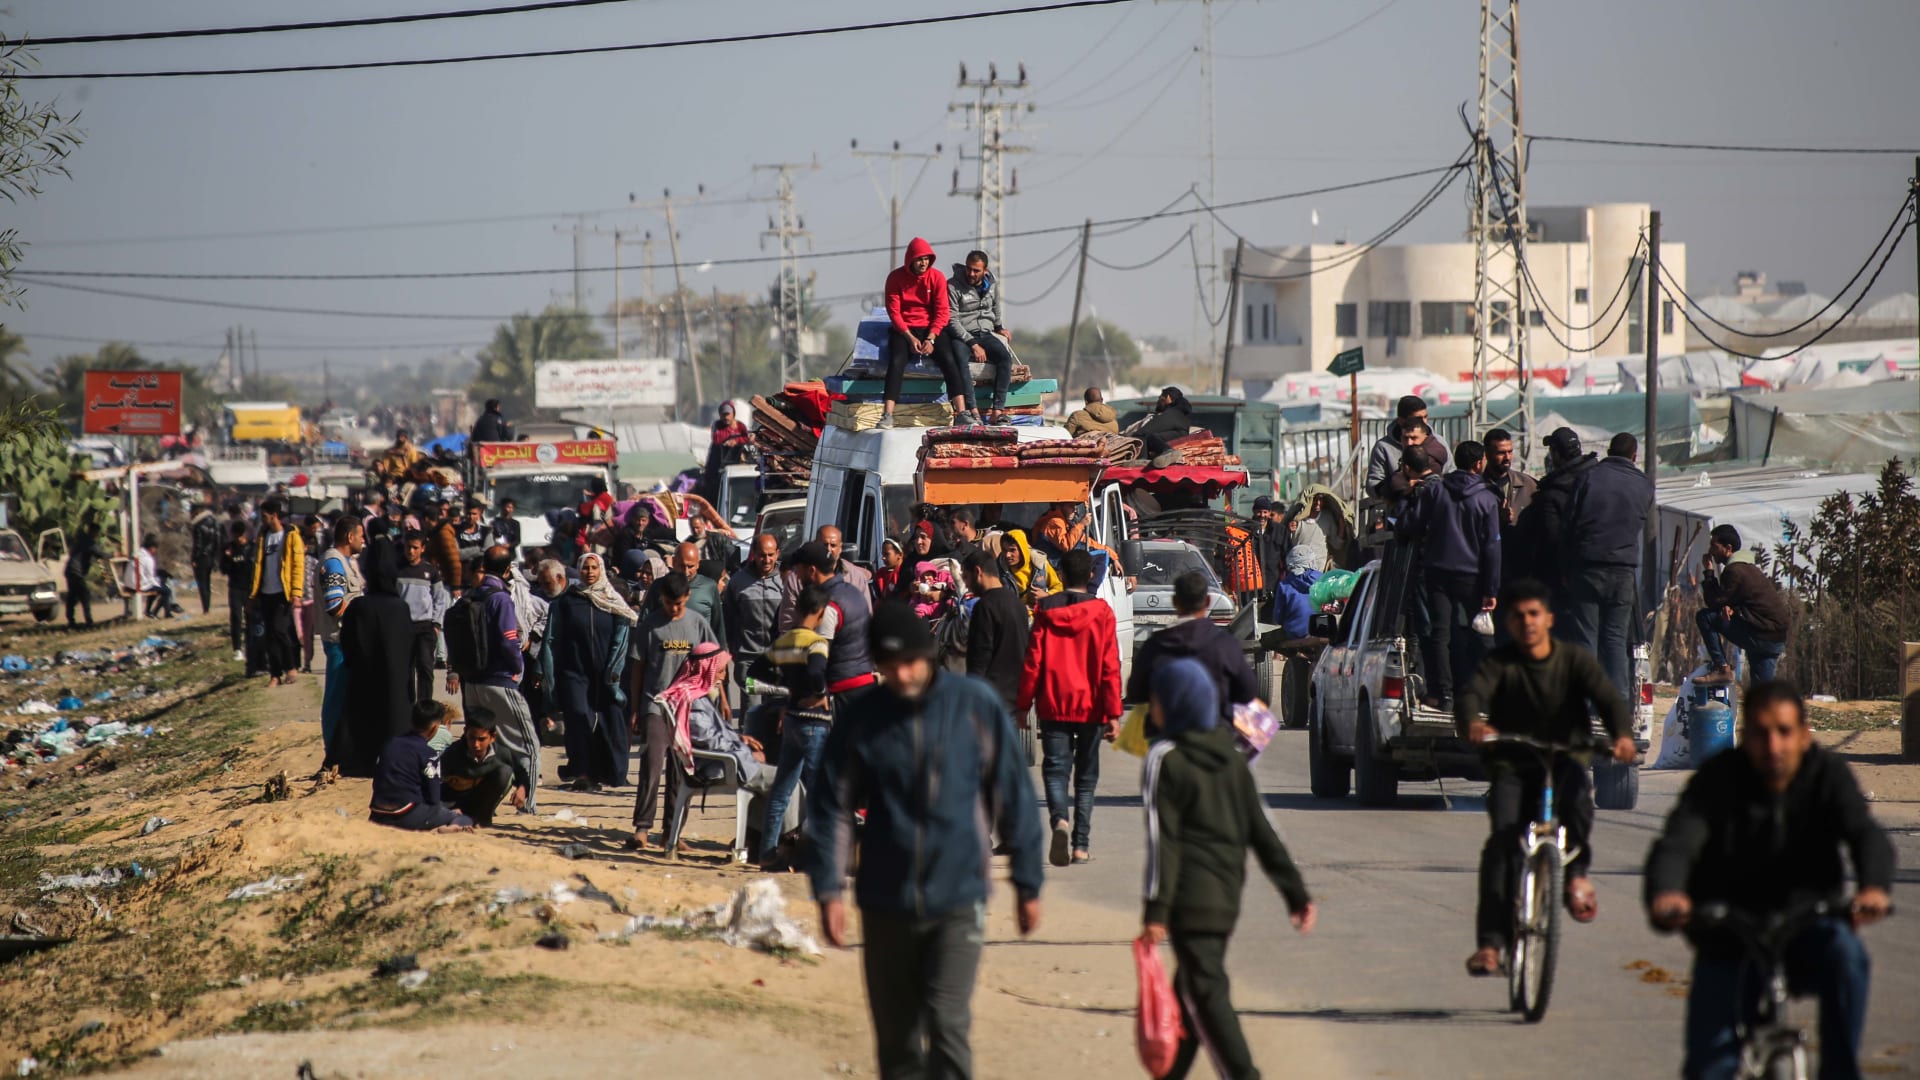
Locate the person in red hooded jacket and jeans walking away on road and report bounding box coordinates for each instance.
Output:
[1014,552,1121,867]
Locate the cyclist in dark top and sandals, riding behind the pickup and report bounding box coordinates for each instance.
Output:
[1453,578,1636,974]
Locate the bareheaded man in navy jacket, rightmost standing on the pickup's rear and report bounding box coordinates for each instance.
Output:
[1542,430,1653,694]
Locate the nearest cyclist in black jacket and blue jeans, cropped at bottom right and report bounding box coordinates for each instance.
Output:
[1645,682,1893,1080]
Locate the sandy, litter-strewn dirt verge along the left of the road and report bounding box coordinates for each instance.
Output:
[0,619,1338,1078]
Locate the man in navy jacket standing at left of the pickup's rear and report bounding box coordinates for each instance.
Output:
[1400,438,1500,709]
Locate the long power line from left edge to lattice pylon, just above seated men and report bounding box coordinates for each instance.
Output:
[30,161,1461,282]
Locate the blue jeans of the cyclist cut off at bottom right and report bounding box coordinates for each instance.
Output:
[1682,920,1872,1080]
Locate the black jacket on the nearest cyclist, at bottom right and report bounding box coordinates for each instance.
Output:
[1645,746,1893,926]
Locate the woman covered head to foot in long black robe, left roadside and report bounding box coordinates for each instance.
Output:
[326,536,415,776]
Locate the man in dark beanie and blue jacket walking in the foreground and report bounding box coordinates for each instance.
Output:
[806,601,1043,1080]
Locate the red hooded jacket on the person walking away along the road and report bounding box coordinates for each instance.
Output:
[1014,592,1121,724]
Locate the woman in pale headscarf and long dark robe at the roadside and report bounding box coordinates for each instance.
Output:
[540,552,639,792]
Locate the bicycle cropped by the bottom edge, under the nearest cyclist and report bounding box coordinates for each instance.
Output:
[1688,899,1893,1080]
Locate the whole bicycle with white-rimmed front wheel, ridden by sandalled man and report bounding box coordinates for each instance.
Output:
[1480,734,1611,1024]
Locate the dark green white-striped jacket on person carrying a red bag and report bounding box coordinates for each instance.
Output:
[1140,726,1309,934]
